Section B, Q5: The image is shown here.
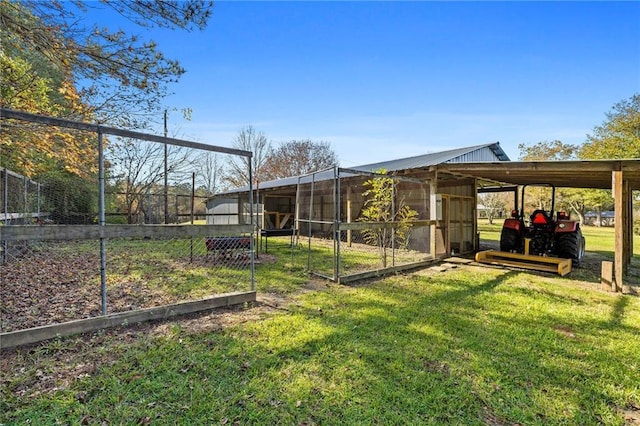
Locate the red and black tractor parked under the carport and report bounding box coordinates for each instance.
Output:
[500,185,585,266]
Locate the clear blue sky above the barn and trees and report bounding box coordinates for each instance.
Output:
[94,1,640,167]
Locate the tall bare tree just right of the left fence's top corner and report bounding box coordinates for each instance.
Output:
[225,126,272,187]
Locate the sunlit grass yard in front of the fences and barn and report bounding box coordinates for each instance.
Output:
[0,225,640,425]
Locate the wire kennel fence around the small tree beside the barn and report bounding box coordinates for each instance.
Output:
[296,168,433,282]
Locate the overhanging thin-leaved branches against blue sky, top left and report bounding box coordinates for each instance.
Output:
[0,0,213,127]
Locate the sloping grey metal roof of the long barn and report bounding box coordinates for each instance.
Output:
[220,142,509,196]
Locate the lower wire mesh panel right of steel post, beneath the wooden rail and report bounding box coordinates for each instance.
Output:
[107,234,252,304]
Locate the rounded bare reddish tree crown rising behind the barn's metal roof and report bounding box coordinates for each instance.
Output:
[263,139,338,180]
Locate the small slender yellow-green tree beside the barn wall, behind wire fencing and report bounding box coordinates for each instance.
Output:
[358,170,418,268]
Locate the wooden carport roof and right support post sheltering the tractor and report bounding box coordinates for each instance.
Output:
[432,159,640,291]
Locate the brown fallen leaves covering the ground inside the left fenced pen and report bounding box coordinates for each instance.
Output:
[0,244,184,332]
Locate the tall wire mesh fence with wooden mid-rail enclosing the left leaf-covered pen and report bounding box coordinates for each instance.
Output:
[0,110,255,333]
